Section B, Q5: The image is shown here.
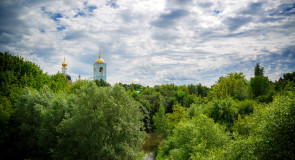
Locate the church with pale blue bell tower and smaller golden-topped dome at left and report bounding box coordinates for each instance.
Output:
[62,50,107,84]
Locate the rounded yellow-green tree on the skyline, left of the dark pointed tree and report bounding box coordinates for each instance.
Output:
[209,73,249,100]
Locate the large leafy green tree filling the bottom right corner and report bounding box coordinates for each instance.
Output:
[256,92,295,159]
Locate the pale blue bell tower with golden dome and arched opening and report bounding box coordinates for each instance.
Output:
[93,50,107,81]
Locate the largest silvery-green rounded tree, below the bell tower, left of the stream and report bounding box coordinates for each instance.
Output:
[55,82,144,159]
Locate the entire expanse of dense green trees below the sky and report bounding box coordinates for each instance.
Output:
[0,53,295,160]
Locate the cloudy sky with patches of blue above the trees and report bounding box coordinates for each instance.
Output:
[0,0,295,86]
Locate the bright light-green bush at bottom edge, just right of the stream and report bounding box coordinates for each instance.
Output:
[157,114,229,160]
